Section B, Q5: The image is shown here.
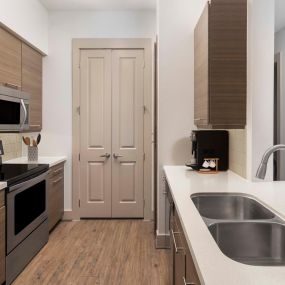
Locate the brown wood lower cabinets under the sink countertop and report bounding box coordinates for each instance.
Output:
[168,189,201,285]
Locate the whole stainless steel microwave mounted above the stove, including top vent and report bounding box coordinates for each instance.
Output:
[0,86,30,132]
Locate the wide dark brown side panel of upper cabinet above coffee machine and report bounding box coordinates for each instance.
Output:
[209,0,247,128]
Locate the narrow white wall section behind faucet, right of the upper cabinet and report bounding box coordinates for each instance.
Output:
[247,0,275,180]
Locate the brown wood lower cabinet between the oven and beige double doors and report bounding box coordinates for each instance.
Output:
[48,163,64,231]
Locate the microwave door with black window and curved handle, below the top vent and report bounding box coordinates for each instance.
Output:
[0,94,29,131]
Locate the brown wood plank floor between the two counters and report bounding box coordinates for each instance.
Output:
[13,220,170,285]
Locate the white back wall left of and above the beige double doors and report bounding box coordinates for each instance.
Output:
[40,11,156,210]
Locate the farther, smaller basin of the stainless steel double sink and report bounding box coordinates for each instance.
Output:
[191,193,275,220]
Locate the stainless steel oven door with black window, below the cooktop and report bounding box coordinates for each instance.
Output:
[7,172,47,254]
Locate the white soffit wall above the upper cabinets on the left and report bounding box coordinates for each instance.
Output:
[0,0,48,54]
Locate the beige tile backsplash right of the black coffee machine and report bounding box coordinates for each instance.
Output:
[229,130,246,178]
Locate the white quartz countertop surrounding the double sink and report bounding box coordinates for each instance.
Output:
[164,166,285,285]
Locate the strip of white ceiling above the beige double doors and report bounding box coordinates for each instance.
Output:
[40,0,155,10]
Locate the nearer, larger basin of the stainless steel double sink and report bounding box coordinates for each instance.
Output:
[209,222,285,266]
